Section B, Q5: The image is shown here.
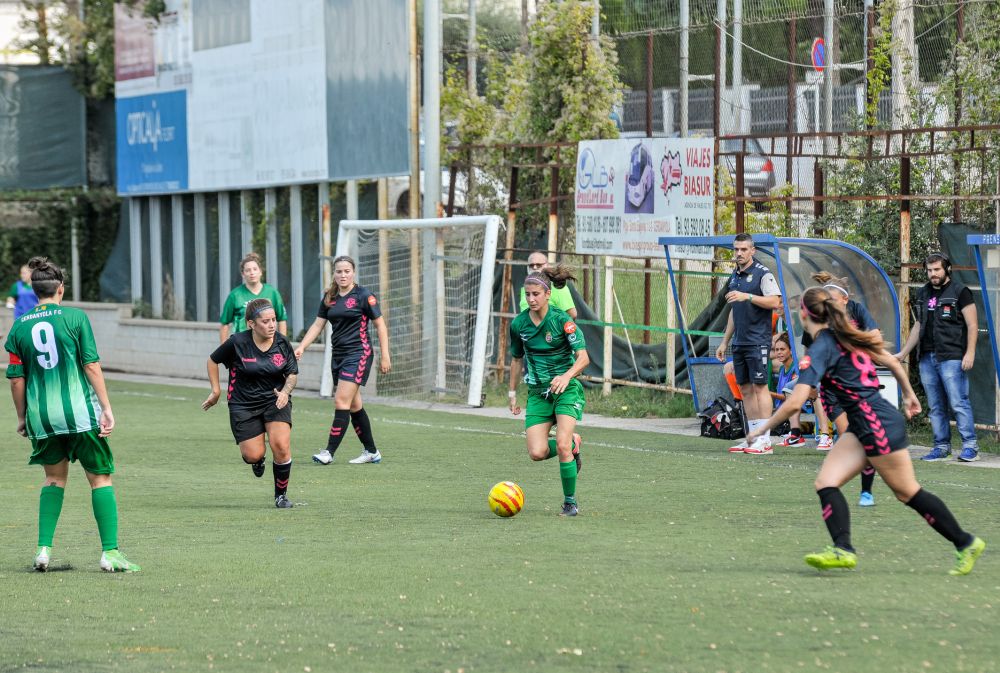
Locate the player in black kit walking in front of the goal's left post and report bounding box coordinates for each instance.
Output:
[295,255,392,465]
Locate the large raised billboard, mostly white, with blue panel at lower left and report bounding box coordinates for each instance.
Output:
[115,0,409,195]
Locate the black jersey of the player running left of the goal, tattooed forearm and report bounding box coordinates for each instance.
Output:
[210,330,299,412]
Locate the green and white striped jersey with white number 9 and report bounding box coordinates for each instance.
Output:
[4,304,101,439]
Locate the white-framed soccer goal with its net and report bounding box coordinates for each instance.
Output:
[321,215,500,407]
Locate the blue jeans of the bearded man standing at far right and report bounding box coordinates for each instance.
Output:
[920,353,979,451]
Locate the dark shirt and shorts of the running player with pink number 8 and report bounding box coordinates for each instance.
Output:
[799,329,907,454]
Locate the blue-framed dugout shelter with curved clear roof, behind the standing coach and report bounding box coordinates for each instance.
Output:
[659,234,900,410]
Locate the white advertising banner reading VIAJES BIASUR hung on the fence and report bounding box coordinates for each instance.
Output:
[575,138,715,259]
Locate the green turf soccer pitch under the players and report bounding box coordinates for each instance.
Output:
[0,382,1000,673]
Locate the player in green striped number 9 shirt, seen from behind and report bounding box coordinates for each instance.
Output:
[5,257,139,572]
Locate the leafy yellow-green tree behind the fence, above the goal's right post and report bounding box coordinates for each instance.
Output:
[441,2,622,243]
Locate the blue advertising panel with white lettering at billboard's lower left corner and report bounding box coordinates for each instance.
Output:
[115,91,188,195]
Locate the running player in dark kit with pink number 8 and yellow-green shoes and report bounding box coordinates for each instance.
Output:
[748,287,986,575]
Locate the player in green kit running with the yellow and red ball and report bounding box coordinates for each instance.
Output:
[509,264,590,516]
